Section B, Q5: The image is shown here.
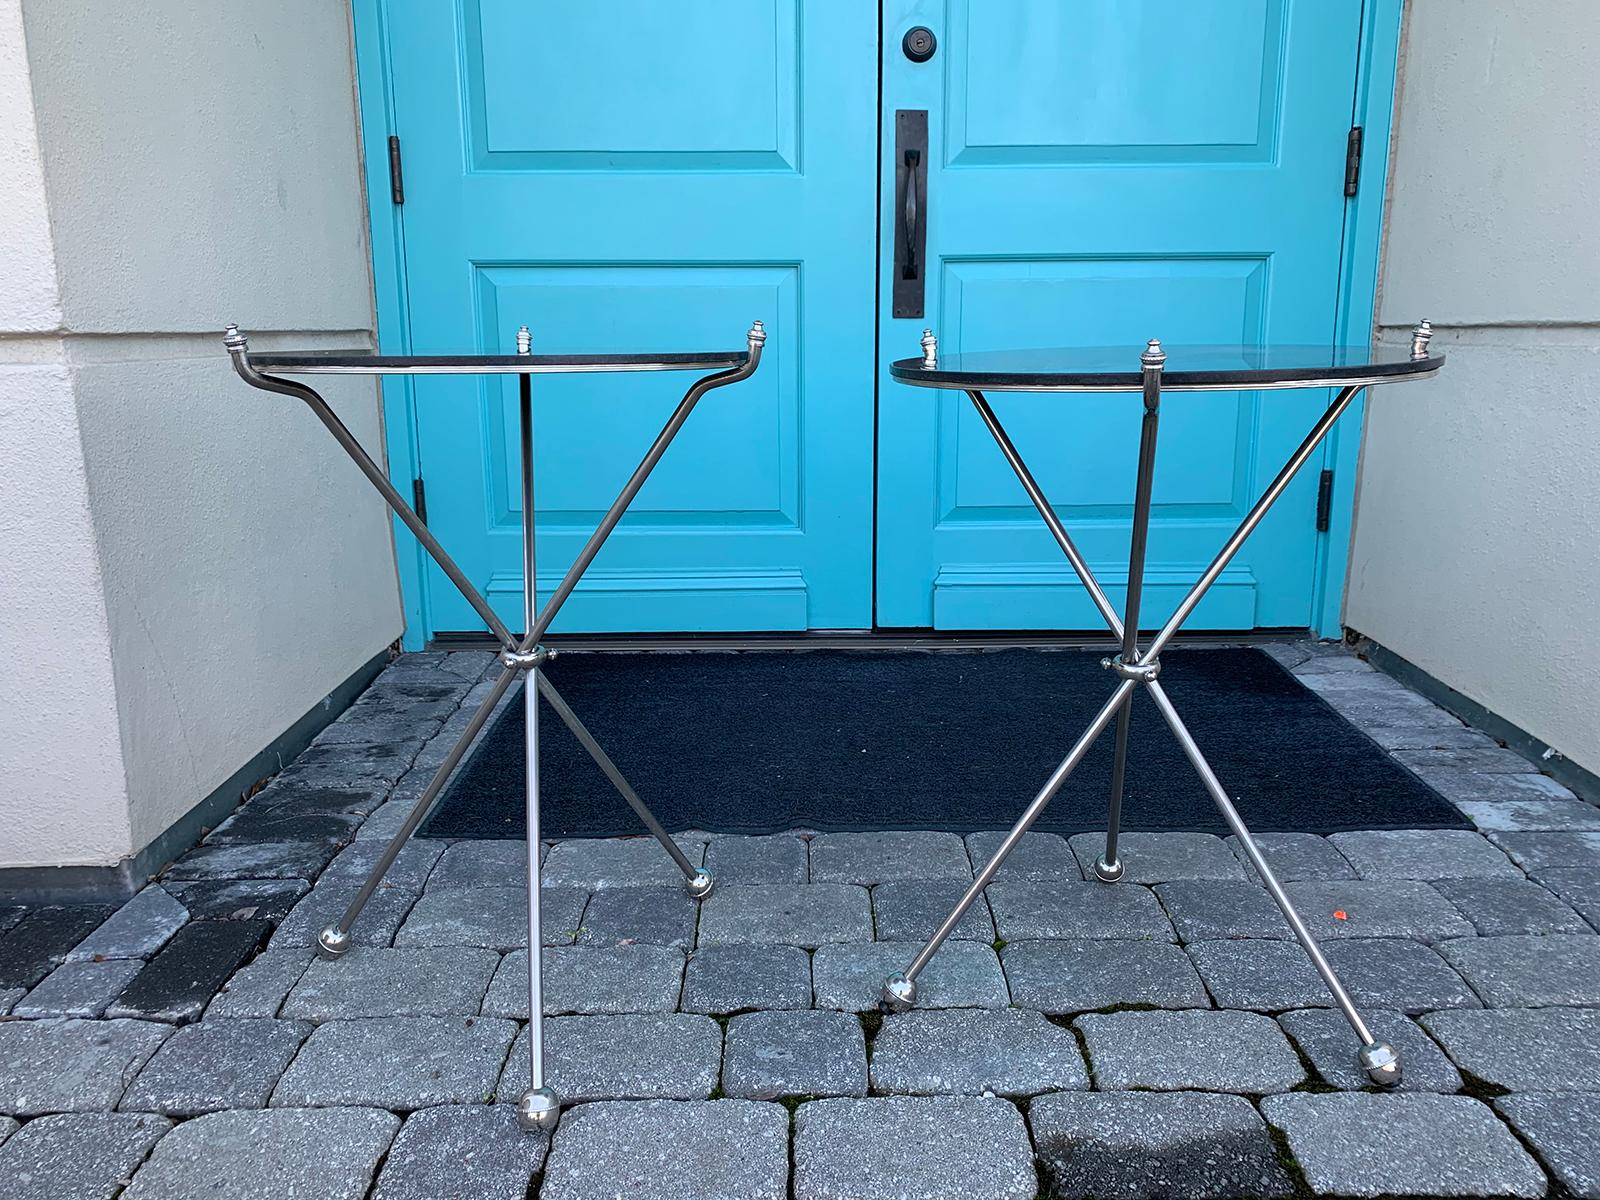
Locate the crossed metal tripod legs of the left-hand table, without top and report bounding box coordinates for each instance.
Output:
[224,322,766,1131]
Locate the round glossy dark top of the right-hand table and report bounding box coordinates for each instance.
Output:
[890,346,1445,392]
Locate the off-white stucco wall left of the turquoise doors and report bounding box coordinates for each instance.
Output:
[0,0,402,866]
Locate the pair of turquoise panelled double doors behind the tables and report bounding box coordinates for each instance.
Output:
[358,0,1362,640]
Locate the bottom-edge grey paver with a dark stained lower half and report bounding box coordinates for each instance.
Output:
[1027,1091,1294,1200]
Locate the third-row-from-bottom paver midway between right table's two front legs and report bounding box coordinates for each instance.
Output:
[1000,938,1211,1013]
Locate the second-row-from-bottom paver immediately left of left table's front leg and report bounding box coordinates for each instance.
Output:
[272,1016,517,1110]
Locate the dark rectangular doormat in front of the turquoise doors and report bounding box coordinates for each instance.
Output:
[422,648,1469,838]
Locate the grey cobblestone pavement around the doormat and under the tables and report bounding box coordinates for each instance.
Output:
[0,643,1600,1200]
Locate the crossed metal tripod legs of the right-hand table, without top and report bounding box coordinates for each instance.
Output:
[883,338,1400,1086]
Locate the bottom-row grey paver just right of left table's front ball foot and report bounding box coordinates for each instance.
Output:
[539,1099,789,1200]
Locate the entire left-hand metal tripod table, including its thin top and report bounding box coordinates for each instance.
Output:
[222,322,766,1130]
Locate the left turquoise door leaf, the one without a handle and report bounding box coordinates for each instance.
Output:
[390,0,877,632]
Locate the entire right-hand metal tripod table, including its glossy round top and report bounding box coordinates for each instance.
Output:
[882,322,1445,1086]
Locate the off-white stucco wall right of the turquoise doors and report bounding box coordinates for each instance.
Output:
[1346,0,1600,771]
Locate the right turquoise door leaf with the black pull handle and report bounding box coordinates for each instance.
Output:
[877,0,1360,629]
